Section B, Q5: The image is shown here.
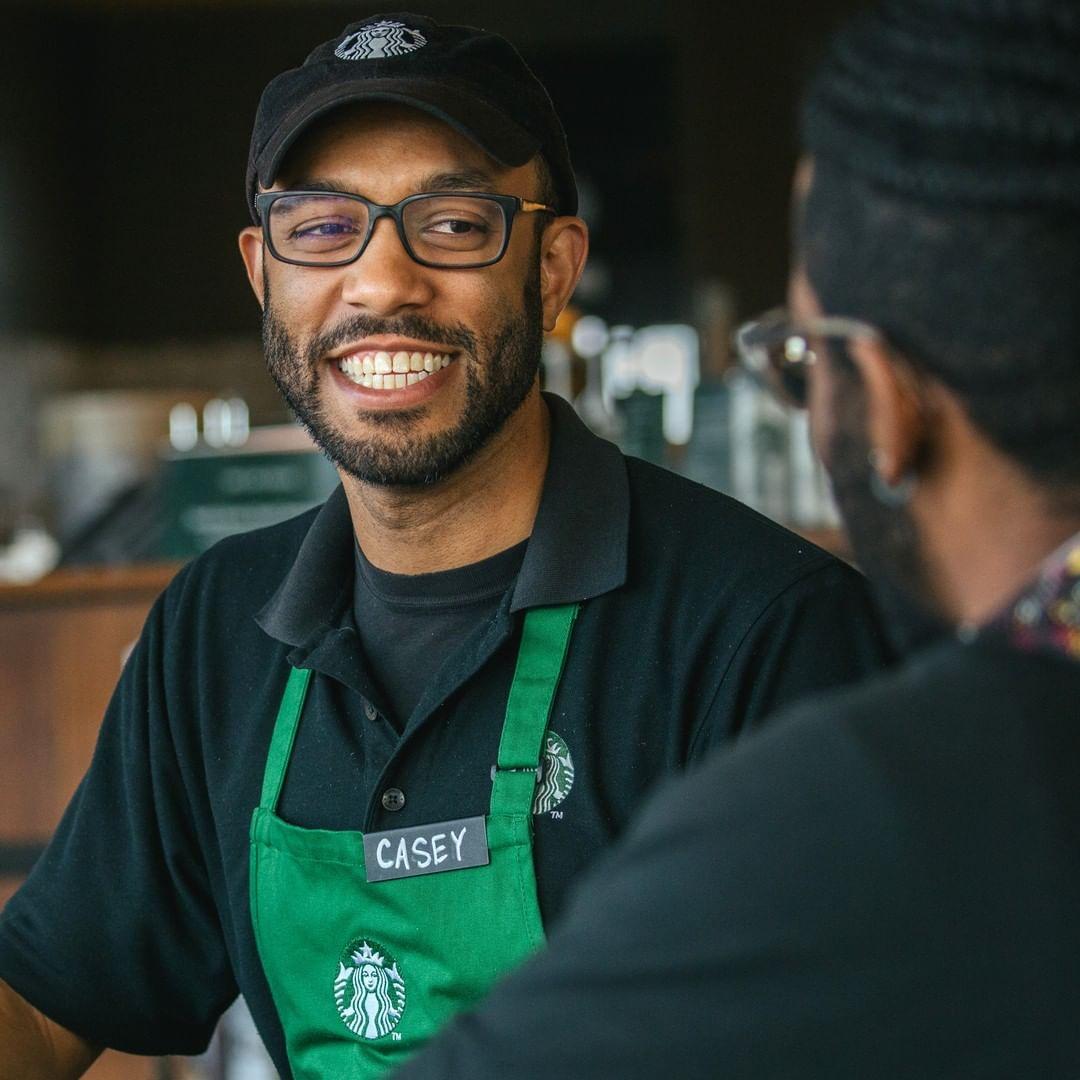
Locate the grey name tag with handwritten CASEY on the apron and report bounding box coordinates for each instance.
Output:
[364,818,491,881]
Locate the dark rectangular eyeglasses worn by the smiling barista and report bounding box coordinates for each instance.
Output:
[255,191,558,270]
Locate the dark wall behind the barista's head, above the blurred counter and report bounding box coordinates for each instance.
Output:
[0,0,852,342]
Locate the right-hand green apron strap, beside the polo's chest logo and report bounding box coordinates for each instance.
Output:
[491,604,581,814]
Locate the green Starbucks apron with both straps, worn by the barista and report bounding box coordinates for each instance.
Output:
[251,605,578,1080]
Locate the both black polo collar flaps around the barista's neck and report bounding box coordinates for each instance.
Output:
[255,394,630,646]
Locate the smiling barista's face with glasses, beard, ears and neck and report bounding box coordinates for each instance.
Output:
[241,104,565,518]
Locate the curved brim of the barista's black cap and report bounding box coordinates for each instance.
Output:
[248,79,540,197]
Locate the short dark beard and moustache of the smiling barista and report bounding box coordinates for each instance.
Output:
[262,267,543,487]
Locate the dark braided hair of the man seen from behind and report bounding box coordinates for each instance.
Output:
[799,0,1080,494]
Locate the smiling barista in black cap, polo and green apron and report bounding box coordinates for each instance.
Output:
[0,14,894,1080]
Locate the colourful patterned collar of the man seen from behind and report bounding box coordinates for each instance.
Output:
[983,532,1080,660]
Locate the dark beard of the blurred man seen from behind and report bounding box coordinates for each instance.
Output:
[826,379,949,653]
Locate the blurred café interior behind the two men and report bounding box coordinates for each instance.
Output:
[0,0,859,1080]
